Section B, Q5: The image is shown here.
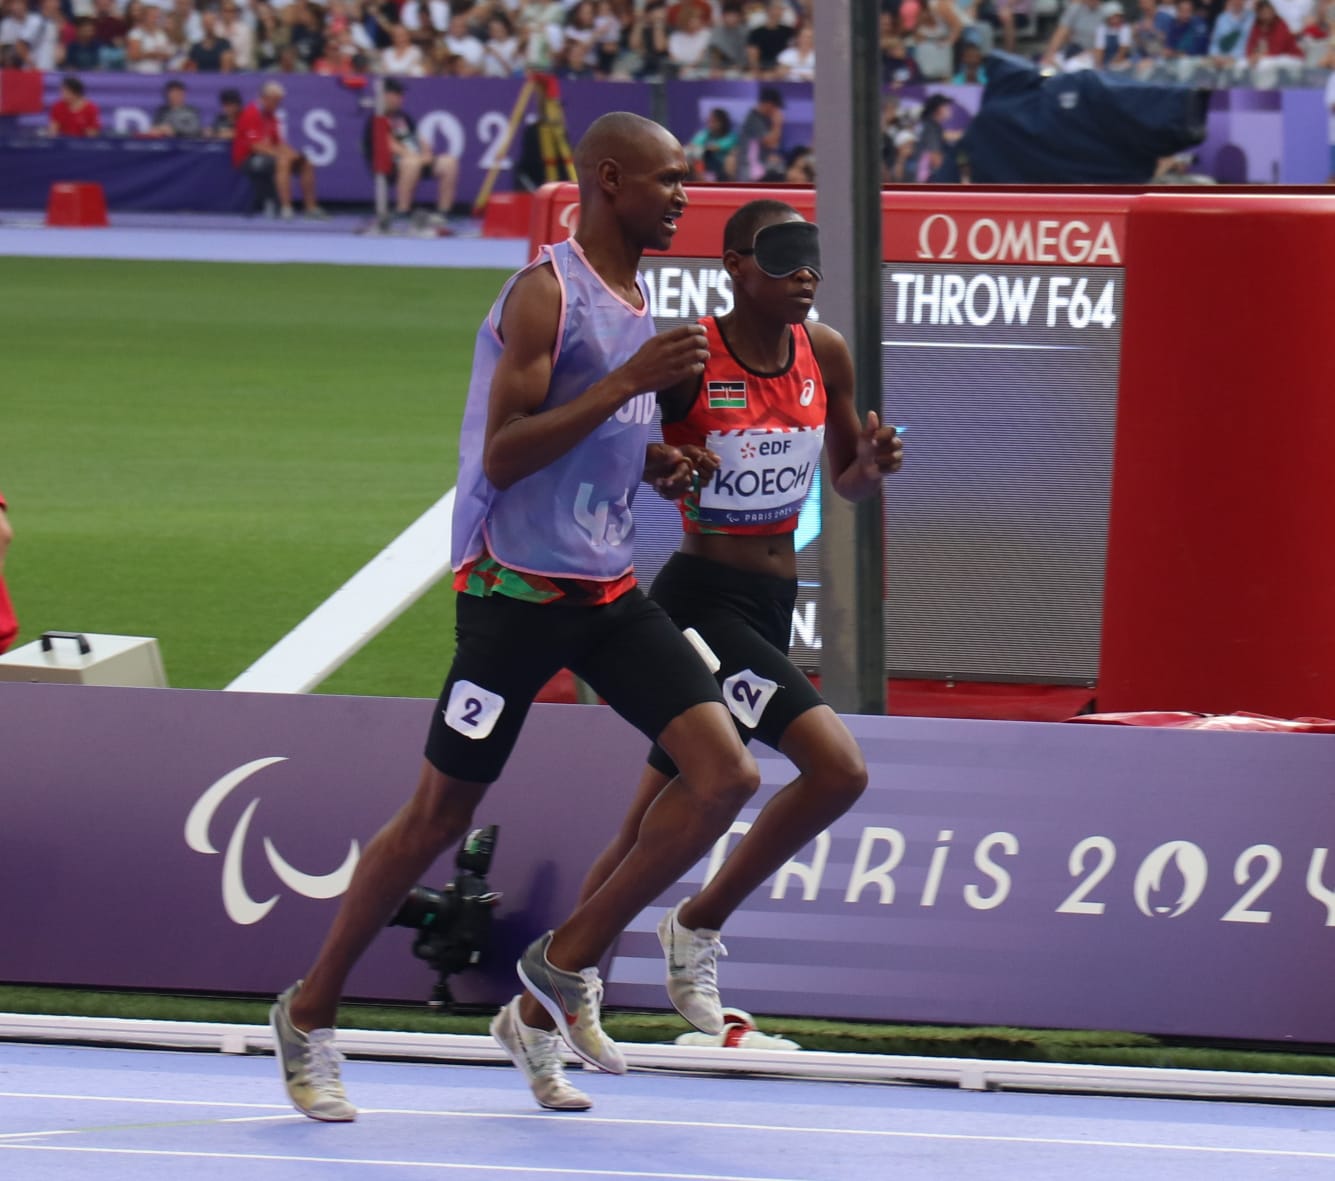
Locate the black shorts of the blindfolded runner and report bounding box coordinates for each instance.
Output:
[649,552,821,775]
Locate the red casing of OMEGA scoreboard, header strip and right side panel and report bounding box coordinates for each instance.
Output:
[533,184,1335,717]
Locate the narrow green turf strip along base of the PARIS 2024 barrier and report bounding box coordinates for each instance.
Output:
[0,985,1335,1076]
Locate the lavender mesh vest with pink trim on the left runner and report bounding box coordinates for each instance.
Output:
[450,239,655,580]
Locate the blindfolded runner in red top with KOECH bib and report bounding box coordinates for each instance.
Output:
[494,199,904,1102]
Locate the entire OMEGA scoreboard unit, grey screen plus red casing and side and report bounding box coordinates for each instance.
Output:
[534,185,1335,717]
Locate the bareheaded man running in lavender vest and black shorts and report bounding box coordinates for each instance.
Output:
[271,112,760,1121]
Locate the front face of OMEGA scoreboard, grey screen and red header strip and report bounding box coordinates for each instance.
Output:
[539,187,1127,685]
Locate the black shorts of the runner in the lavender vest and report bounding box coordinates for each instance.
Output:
[426,587,720,783]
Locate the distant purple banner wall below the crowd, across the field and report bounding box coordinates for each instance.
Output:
[7,73,1328,203]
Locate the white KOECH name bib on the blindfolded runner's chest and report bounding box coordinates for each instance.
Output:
[700,426,825,524]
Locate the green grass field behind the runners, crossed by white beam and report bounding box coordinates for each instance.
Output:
[0,258,505,697]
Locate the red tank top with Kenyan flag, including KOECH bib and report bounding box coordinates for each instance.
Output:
[662,316,825,534]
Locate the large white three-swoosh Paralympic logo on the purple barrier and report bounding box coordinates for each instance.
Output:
[186,757,360,926]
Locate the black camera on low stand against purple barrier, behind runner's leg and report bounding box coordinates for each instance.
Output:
[388,825,501,1009]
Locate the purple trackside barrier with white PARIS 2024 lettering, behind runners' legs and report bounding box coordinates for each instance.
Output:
[0,685,1335,1042]
